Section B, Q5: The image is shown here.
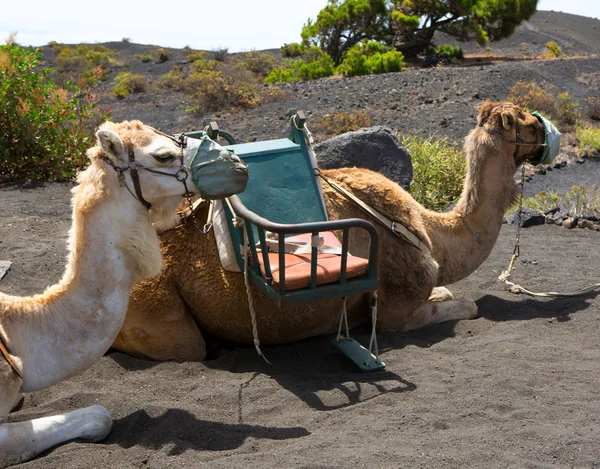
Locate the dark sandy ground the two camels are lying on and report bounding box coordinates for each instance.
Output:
[0,158,600,469]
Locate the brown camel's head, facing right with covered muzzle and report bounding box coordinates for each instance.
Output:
[471,101,560,167]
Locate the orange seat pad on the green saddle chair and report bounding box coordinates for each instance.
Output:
[258,231,369,291]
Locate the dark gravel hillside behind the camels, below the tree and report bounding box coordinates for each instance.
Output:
[36,11,600,144]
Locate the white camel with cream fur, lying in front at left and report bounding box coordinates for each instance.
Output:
[0,121,247,467]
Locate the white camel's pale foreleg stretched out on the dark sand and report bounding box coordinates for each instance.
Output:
[0,405,112,467]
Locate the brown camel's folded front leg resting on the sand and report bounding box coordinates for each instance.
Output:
[402,298,477,331]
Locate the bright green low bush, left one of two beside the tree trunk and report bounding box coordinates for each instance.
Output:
[265,47,335,84]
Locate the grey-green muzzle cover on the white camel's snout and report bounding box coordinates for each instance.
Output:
[190,136,248,200]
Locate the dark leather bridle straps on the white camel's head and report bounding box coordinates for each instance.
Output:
[100,126,194,210]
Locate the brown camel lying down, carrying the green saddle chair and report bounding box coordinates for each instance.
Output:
[114,102,544,360]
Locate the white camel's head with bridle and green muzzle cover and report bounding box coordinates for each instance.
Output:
[88,121,248,208]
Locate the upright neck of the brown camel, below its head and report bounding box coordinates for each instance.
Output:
[426,147,516,286]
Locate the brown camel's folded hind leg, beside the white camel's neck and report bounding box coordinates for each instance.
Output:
[113,277,206,361]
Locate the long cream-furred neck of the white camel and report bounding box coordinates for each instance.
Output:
[2,171,160,392]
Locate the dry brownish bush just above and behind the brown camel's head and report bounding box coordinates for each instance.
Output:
[508,82,579,130]
